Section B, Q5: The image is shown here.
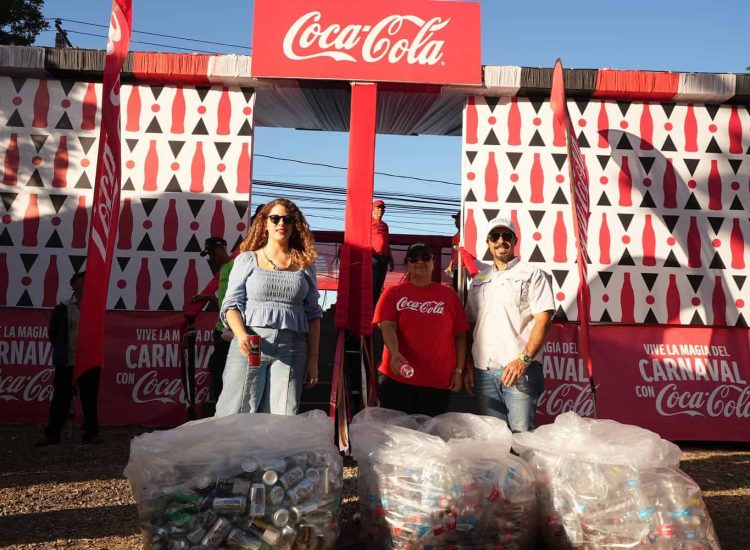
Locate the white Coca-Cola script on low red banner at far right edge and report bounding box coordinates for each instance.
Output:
[656,384,750,418]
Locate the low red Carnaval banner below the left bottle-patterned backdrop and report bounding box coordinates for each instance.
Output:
[0,309,216,426]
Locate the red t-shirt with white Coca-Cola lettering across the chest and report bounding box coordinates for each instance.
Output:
[372,282,469,389]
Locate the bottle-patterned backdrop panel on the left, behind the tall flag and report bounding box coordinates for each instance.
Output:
[0,77,255,310]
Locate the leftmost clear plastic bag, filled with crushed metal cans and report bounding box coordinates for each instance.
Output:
[125,411,343,550]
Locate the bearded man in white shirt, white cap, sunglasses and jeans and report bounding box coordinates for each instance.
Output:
[464,215,555,432]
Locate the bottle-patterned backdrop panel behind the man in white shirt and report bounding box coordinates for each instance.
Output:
[462,97,750,327]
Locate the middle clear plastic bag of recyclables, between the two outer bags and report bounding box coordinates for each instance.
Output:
[350,408,537,549]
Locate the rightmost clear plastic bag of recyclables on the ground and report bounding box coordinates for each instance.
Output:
[513,412,719,550]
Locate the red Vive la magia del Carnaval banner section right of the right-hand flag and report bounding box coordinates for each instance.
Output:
[591,326,750,441]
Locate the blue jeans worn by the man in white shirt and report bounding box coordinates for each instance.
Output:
[474,362,544,433]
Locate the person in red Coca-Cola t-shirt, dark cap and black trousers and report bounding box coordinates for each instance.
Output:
[372,243,469,416]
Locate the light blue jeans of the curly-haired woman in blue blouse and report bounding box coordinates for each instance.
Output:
[216,327,307,416]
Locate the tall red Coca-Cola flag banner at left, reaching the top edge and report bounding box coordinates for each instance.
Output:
[73,0,133,380]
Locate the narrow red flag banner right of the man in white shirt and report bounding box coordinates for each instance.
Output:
[550,59,596,406]
